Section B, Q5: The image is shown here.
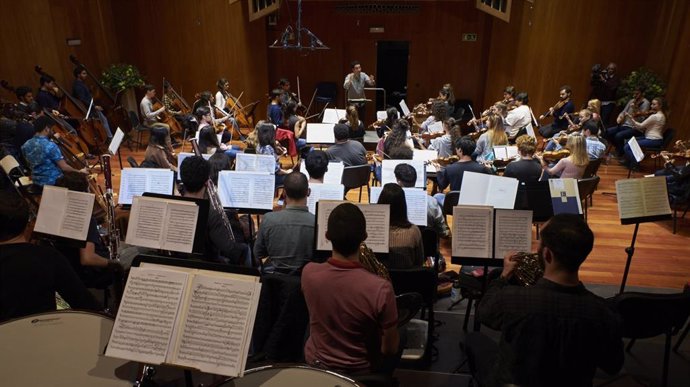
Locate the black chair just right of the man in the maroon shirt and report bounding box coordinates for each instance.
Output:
[388,267,438,364]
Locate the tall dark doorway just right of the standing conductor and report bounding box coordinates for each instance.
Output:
[376,41,410,111]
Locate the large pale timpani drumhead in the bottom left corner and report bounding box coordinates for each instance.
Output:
[0,310,138,387]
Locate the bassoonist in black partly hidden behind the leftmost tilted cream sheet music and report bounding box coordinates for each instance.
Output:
[55,172,124,289]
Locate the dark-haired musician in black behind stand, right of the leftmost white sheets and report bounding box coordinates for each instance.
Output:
[180,156,252,266]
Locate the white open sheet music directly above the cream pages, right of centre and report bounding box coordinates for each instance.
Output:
[458,172,519,209]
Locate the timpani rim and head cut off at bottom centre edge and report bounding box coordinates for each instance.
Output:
[211,365,360,387]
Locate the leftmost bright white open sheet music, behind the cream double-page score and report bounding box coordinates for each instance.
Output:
[118,168,174,204]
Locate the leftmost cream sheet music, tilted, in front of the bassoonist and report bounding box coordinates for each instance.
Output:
[34,185,95,241]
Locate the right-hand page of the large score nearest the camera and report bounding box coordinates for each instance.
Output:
[174,275,261,376]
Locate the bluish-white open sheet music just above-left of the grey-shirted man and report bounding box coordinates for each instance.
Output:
[218,171,275,210]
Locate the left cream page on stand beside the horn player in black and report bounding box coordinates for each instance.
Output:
[451,206,492,258]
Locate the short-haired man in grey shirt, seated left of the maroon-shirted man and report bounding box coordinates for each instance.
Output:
[254,172,316,275]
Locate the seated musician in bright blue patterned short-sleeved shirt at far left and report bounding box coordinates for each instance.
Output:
[22,116,89,188]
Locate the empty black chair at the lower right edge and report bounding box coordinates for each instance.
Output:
[610,292,690,386]
